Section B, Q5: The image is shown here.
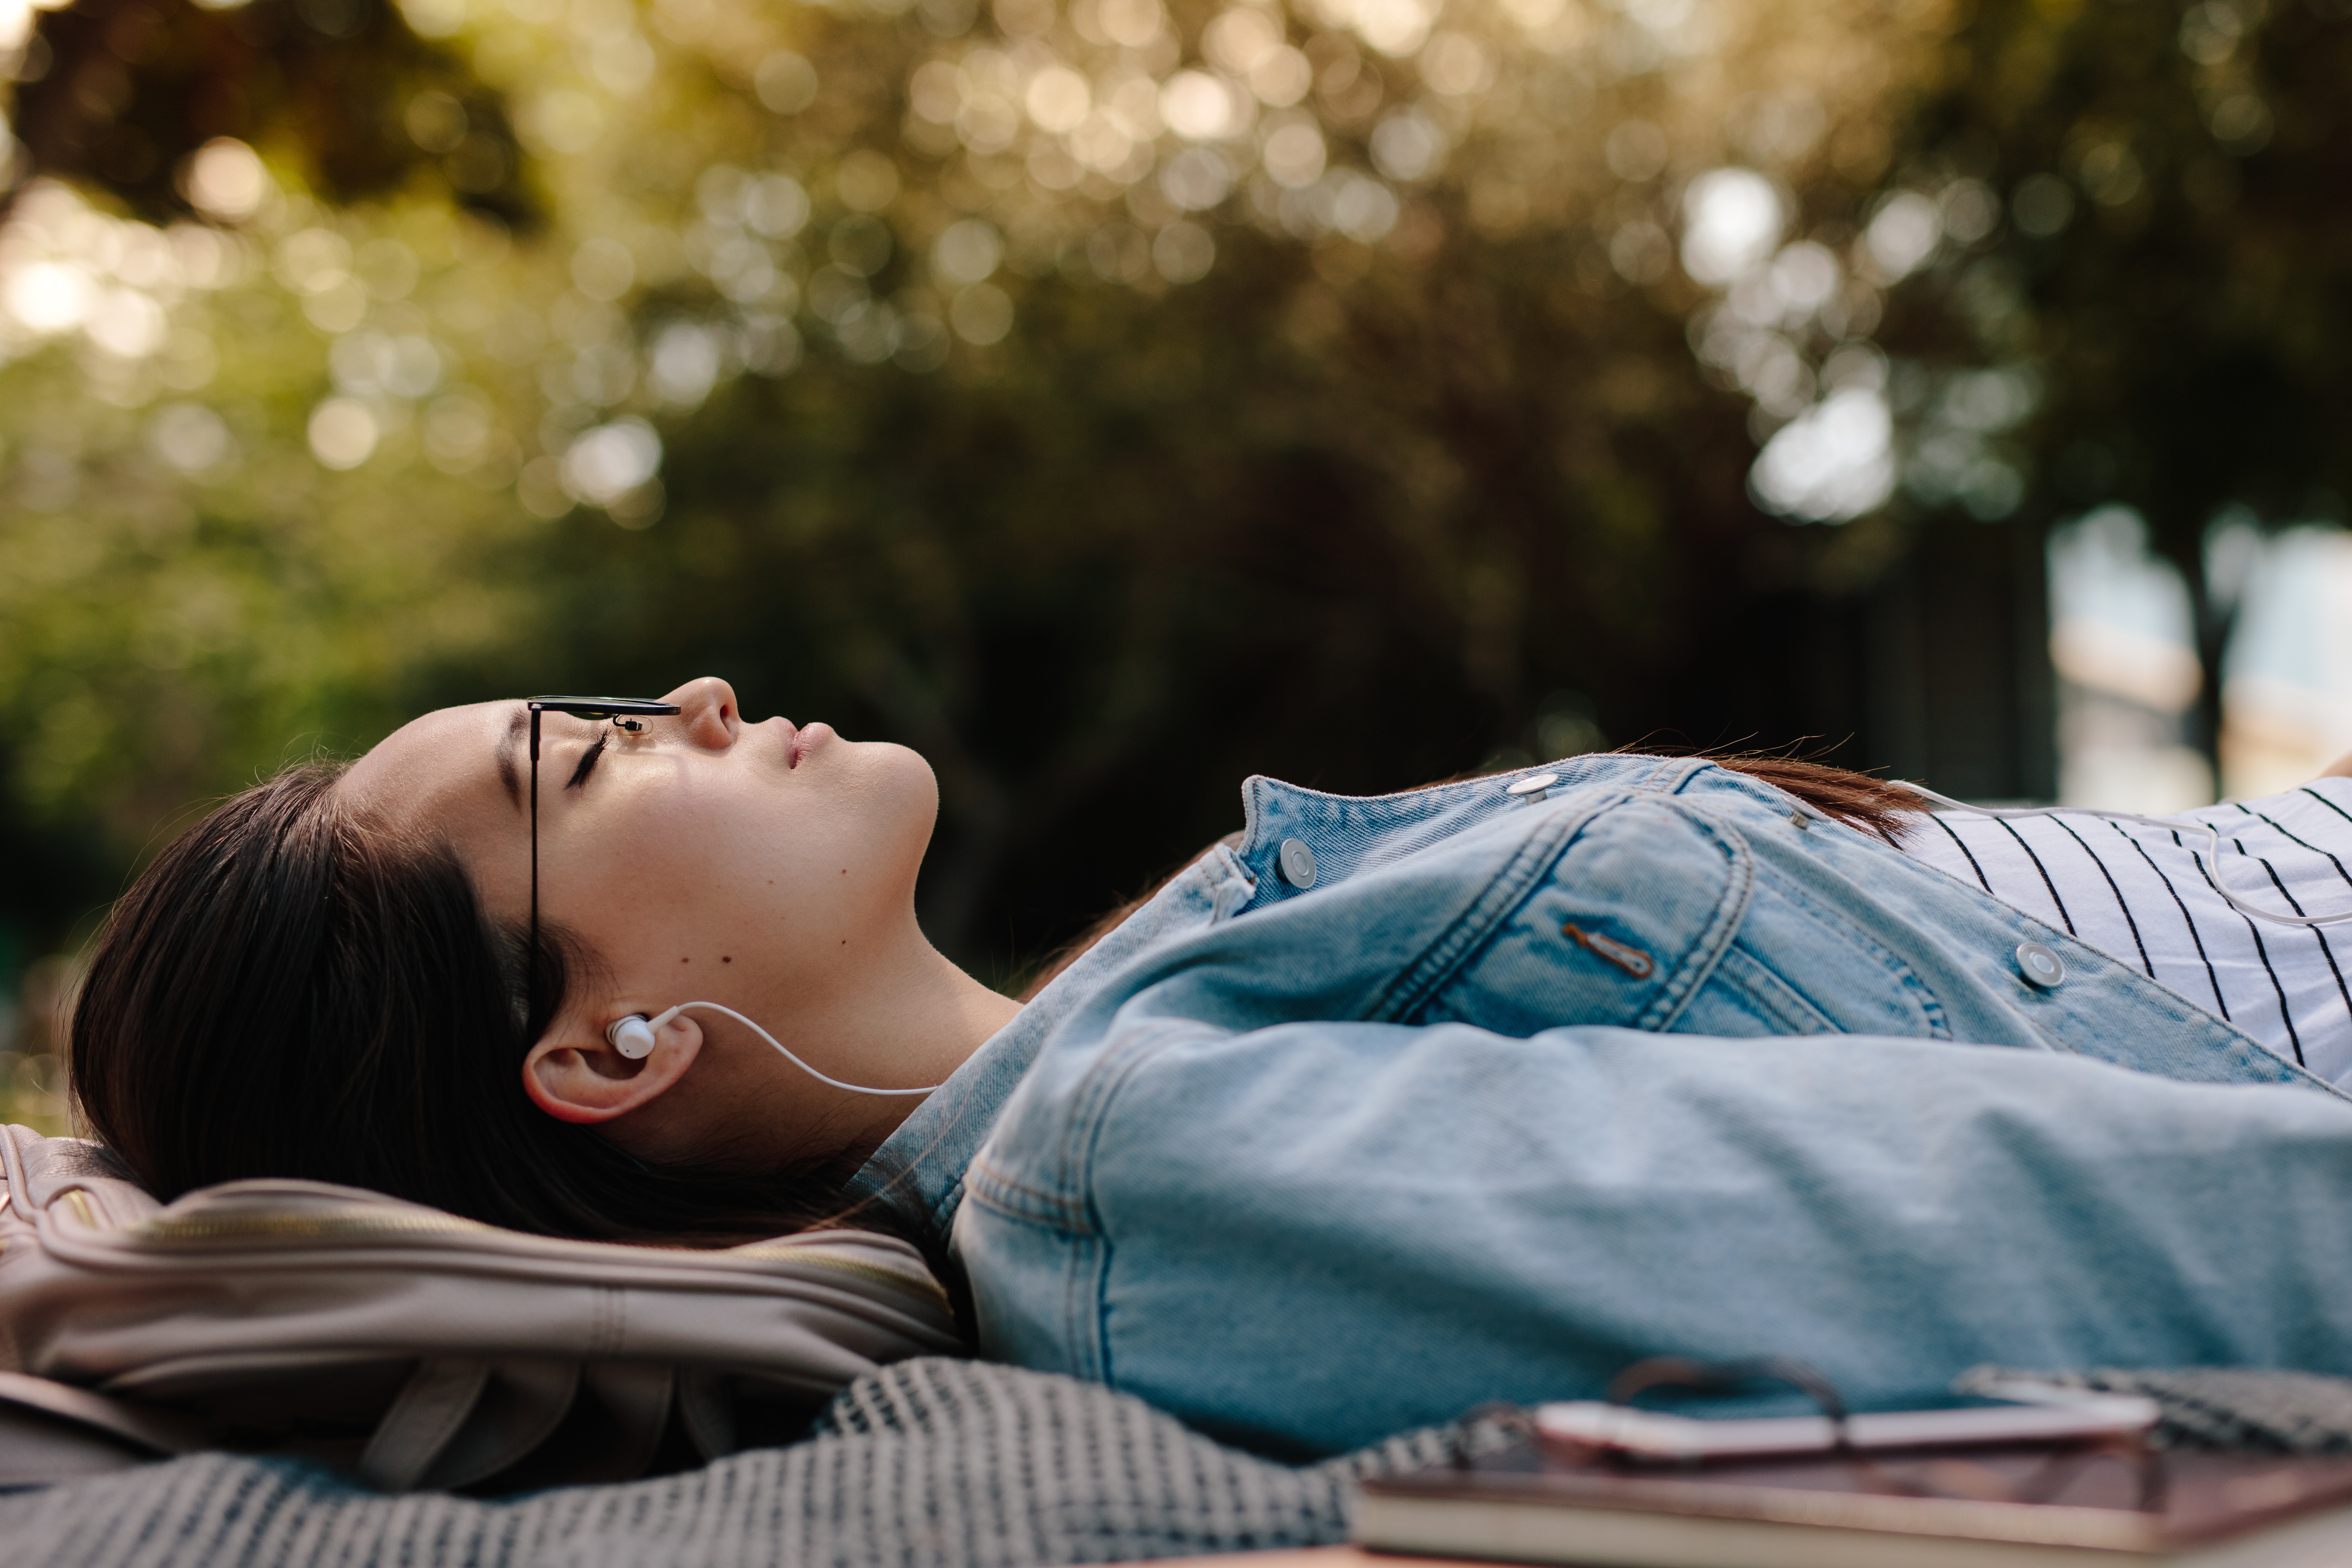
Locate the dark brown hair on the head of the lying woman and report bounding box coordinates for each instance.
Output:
[71,762,898,1241]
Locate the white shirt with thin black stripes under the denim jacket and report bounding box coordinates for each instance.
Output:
[1903,778,2352,1084]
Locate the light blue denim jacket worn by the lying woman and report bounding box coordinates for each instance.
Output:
[859,757,2352,1453]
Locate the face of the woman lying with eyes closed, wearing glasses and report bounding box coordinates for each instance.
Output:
[343,677,938,1032]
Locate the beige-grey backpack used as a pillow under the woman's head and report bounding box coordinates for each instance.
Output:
[0,1126,962,1493]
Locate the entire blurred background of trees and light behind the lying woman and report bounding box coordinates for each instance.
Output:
[0,0,2352,1142]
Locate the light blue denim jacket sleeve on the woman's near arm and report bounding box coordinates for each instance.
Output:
[955,1018,2352,1453]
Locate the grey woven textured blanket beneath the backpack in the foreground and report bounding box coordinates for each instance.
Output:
[0,1359,1491,1568]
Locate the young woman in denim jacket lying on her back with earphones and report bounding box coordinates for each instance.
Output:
[73,680,2352,1453]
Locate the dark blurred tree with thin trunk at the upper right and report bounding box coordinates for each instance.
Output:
[1860,0,2352,766]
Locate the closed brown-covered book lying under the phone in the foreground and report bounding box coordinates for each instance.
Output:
[1355,1408,2352,1568]
